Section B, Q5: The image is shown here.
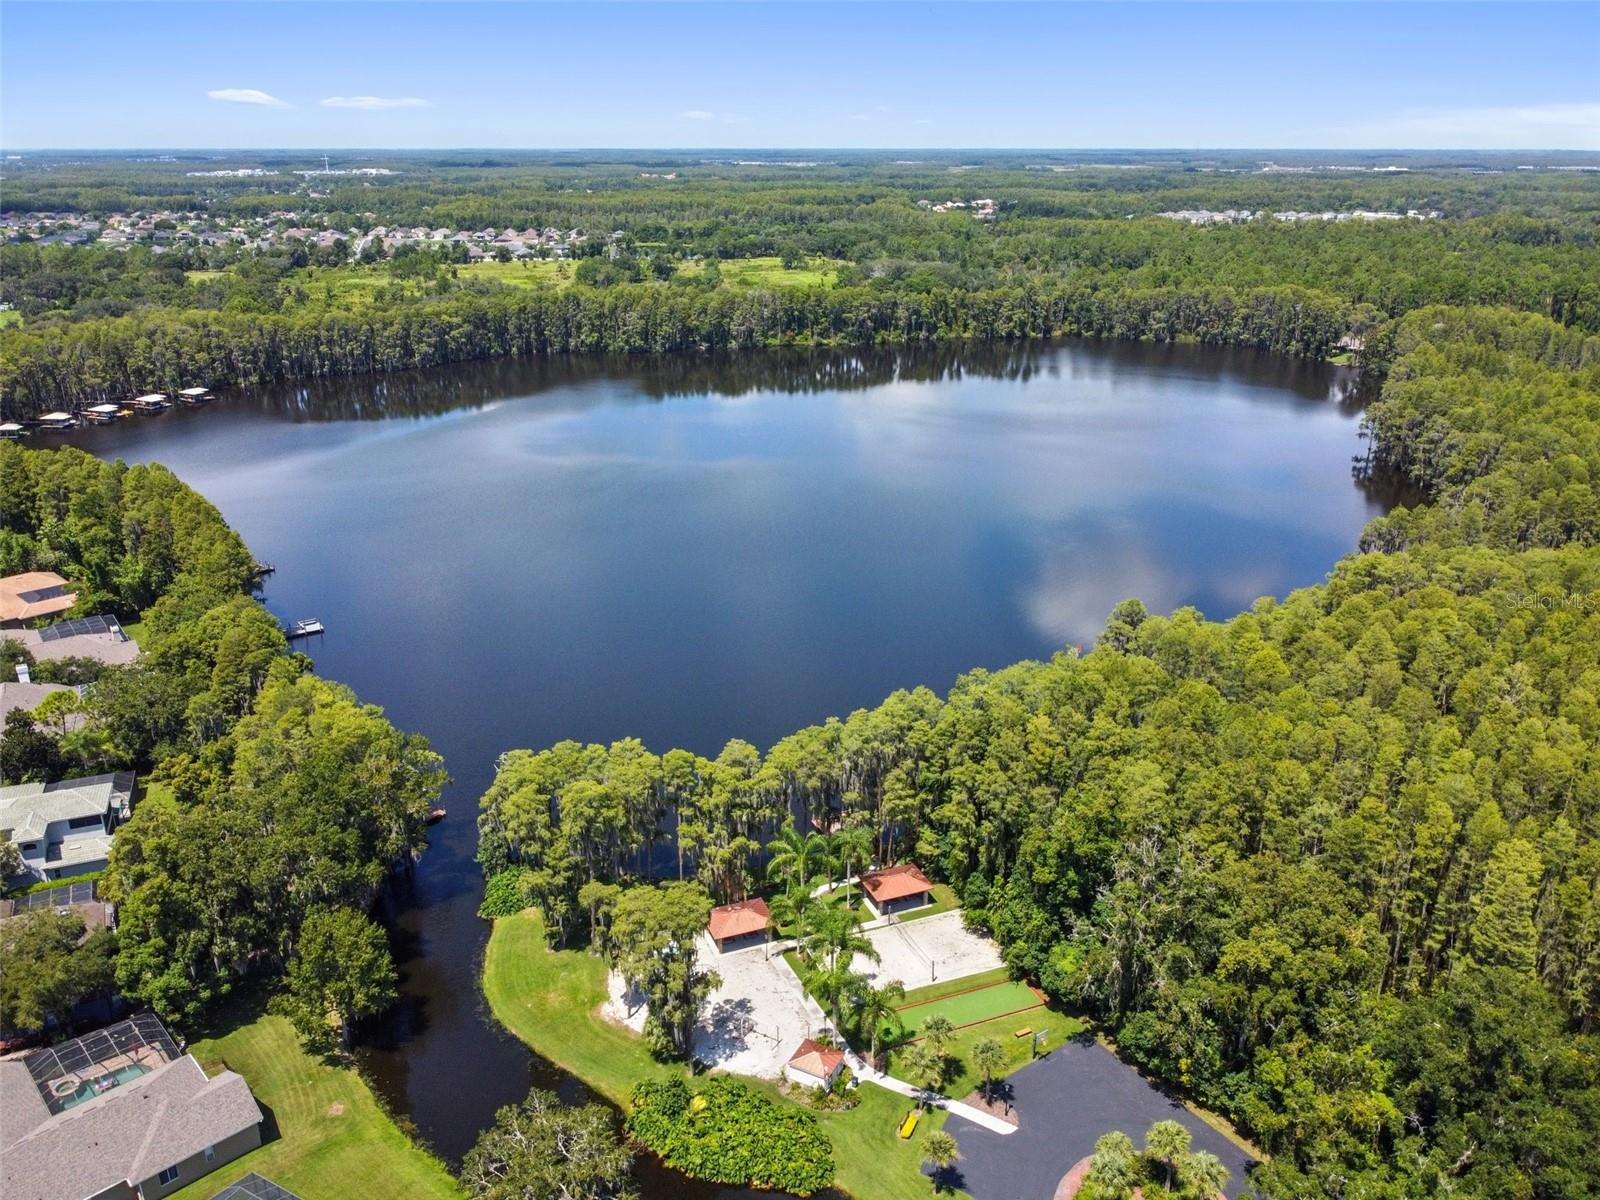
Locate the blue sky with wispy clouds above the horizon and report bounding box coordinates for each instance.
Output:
[0,0,1600,150]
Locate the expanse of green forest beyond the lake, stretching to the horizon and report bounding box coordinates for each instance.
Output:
[0,157,1600,418]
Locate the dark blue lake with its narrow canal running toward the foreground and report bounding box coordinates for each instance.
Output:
[50,342,1390,1197]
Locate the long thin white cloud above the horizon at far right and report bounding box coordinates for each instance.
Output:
[1339,104,1600,150]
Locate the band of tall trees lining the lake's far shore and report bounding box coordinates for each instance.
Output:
[0,285,1362,418]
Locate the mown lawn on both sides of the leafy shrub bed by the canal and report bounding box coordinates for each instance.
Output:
[483,910,944,1200]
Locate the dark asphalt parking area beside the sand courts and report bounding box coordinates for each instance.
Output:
[944,1040,1254,1200]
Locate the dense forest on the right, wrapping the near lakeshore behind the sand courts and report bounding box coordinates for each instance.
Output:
[480,307,1600,1200]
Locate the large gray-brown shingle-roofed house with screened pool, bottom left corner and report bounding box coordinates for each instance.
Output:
[0,1036,262,1200]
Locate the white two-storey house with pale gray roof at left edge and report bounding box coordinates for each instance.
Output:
[0,771,134,880]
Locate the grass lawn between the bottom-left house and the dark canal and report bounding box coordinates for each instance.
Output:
[174,1013,462,1200]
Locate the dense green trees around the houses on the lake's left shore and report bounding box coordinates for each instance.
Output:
[0,443,445,1040]
